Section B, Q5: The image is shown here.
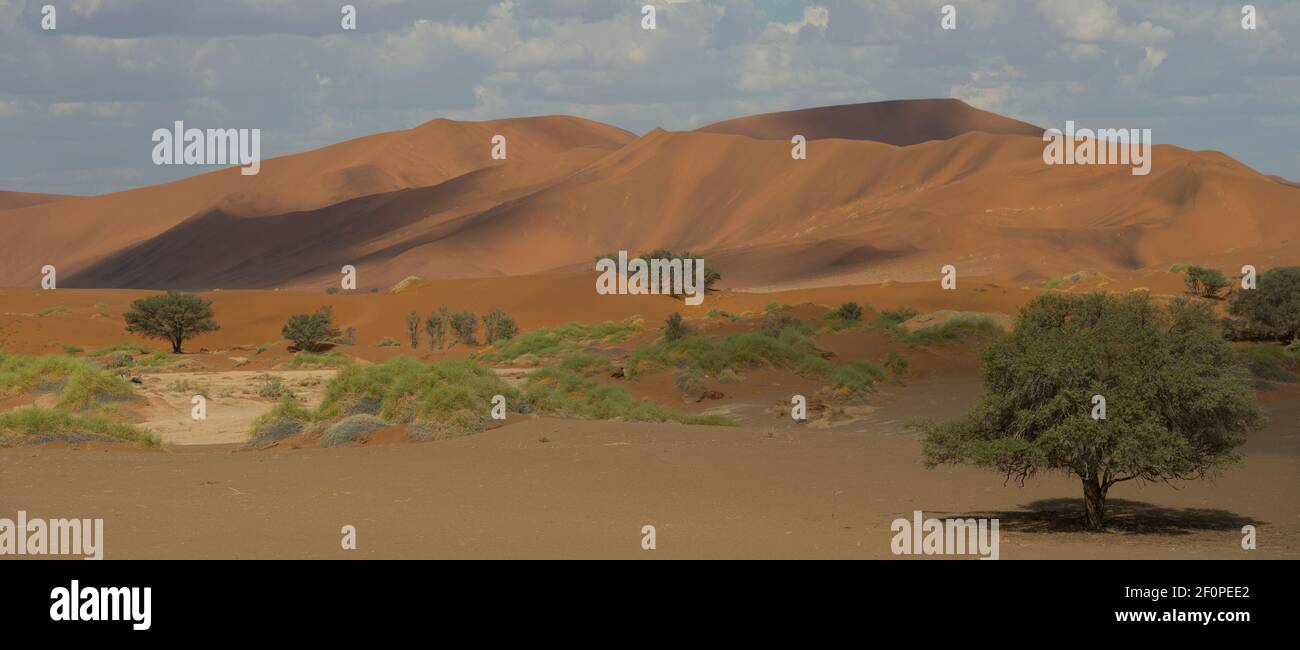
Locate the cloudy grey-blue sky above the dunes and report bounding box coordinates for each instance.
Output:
[0,0,1300,194]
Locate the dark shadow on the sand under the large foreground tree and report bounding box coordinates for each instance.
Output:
[935,498,1265,536]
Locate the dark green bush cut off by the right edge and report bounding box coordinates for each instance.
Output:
[1227,267,1300,343]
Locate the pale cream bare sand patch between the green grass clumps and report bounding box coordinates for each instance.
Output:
[138,369,335,445]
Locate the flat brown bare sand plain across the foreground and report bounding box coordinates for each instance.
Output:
[0,382,1300,559]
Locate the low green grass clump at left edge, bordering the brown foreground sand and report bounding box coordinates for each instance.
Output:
[0,407,160,447]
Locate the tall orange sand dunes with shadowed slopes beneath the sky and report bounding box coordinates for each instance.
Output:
[0,100,1300,290]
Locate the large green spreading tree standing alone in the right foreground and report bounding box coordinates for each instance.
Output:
[920,293,1261,530]
